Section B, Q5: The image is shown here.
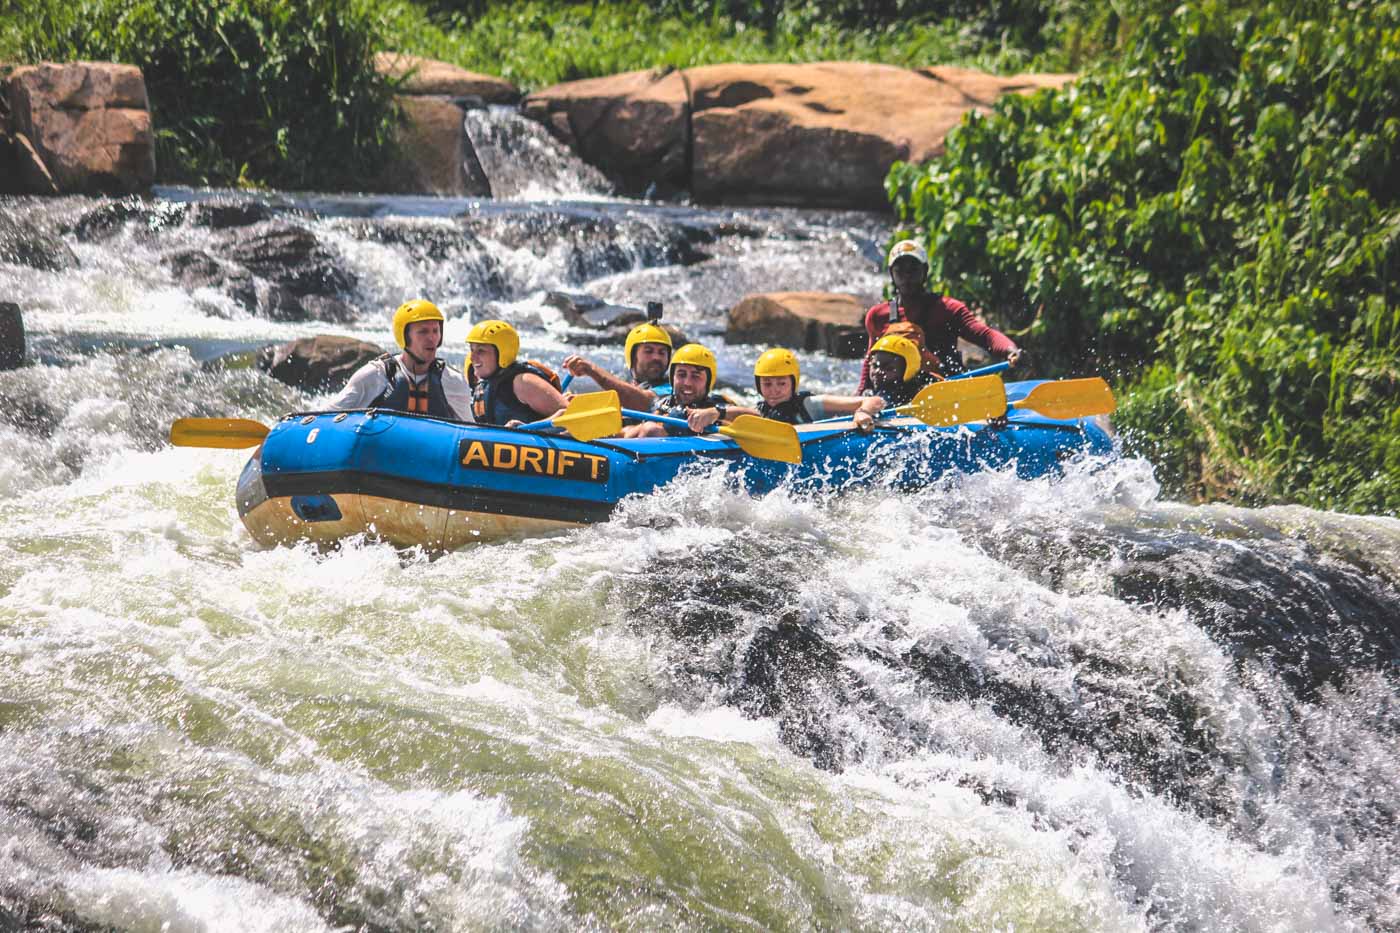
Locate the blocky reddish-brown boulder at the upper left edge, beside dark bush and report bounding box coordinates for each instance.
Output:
[6,62,155,195]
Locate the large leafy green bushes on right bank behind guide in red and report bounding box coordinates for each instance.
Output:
[889,0,1400,514]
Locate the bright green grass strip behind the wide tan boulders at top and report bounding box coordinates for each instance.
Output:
[391,0,1085,90]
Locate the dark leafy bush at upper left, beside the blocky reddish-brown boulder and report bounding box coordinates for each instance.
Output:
[0,0,393,189]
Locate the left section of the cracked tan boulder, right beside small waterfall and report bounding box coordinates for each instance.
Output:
[524,70,690,193]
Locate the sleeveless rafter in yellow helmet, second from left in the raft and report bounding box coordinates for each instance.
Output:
[466,321,568,427]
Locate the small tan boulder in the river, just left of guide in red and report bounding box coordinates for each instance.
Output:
[724,291,874,359]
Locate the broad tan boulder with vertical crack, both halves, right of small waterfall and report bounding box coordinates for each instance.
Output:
[524,62,1072,209]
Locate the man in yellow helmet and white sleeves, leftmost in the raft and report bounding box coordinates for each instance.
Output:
[330,298,472,422]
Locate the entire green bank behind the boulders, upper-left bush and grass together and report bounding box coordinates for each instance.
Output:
[0,0,1089,189]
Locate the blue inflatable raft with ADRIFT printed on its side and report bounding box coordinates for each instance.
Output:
[238,382,1114,551]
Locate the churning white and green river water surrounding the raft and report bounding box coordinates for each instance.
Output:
[0,112,1400,930]
